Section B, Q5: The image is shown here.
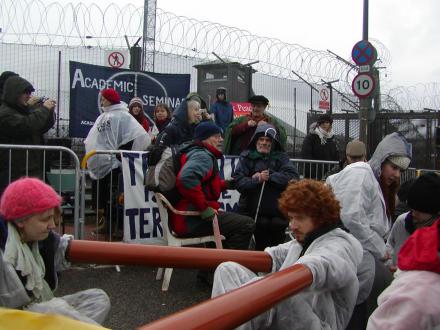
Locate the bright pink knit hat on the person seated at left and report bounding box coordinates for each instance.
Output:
[0,177,61,221]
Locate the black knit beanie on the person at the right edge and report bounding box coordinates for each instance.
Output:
[408,173,440,214]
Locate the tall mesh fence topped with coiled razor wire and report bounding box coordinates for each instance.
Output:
[0,0,440,146]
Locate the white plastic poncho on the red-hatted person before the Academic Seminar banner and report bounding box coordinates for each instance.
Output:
[84,104,151,180]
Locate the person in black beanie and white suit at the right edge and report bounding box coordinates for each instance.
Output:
[387,173,440,270]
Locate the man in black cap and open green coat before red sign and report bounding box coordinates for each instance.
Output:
[223,95,287,155]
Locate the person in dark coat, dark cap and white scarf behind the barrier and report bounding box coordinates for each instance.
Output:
[301,114,340,180]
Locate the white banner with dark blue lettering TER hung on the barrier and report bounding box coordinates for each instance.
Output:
[121,152,240,244]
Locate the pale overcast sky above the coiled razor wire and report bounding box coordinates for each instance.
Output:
[153,0,440,86]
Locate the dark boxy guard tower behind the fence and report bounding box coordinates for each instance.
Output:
[194,61,256,107]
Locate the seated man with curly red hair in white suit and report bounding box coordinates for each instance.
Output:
[212,180,362,329]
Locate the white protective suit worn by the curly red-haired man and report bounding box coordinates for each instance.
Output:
[212,229,362,330]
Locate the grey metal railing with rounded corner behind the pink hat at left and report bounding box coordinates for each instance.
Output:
[0,144,84,238]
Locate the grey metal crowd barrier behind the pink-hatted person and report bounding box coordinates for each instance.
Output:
[0,144,84,238]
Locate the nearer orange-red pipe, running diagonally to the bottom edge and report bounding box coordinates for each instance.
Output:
[139,265,313,330]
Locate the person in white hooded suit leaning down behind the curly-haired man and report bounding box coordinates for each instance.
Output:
[326,133,412,325]
